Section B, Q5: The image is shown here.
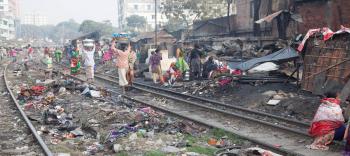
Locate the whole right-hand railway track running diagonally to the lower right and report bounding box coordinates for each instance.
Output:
[54,63,339,156]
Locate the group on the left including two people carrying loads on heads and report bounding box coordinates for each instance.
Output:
[63,38,136,93]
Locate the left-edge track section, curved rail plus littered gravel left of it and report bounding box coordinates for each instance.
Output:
[0,62,53,156]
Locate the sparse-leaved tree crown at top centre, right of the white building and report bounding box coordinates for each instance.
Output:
[161,0,227,26]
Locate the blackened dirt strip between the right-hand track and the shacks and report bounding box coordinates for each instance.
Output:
[96,61,321,122]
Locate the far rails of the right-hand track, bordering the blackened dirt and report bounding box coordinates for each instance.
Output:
[95,74,310,137]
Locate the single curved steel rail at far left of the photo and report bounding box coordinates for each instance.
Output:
[3,65,53,156]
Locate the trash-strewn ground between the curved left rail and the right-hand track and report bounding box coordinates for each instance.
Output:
[4,57,252,156]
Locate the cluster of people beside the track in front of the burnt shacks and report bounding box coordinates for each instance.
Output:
[149,44,223,85]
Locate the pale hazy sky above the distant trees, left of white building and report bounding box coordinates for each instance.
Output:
[20,0,117,25]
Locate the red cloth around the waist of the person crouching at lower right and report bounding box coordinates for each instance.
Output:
[309,121,343,137]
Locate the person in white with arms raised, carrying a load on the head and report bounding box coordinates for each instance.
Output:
[83,39,95,82]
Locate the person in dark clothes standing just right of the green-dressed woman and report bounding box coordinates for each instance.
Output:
[190,44,202,80]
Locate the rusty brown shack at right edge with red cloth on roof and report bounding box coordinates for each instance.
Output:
[299,28,350,95]
